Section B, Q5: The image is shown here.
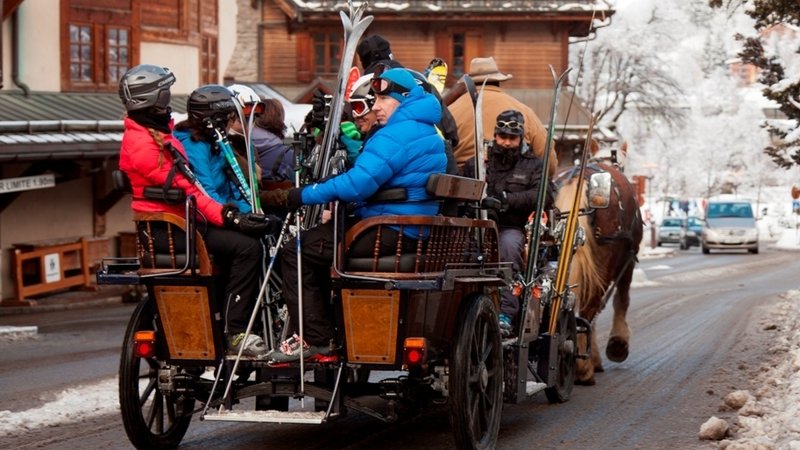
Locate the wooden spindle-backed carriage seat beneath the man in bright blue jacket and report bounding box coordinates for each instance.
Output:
[343,174,497,278]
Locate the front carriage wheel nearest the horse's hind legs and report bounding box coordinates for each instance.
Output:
[544,311,578,403]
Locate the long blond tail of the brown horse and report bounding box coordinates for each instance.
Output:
[555,178,604,320]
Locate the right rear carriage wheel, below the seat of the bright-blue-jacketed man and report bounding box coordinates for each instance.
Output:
[449,295,503,449]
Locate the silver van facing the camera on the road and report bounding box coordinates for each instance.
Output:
[701,201,758,254]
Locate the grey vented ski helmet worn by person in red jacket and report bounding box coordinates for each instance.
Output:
[119,64,175,111]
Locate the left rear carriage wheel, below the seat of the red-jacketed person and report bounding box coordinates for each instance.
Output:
[119,299,194,449]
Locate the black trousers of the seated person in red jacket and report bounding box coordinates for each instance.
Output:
[143,225,264,334]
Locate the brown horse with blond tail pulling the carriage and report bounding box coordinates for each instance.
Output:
[556,163,642,385]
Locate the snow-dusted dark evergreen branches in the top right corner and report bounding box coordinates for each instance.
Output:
[709,0,800,168]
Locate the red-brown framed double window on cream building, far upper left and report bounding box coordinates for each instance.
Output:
[69,24,131,90]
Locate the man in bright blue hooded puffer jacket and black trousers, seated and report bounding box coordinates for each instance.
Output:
[268,68,447,362]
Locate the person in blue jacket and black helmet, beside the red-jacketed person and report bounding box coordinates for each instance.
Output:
[174,84,252,213]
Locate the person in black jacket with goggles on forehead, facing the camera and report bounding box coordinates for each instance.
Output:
[465,109,554,337]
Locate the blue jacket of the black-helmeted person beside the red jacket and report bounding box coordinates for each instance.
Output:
[173,129,251,213]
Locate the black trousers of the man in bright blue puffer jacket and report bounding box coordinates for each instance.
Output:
[281,218,416,346]
